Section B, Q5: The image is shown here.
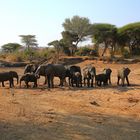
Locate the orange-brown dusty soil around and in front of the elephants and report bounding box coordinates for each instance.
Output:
[0,60,140,140]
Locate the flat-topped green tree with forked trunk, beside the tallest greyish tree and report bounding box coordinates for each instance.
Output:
[92,23,117,56]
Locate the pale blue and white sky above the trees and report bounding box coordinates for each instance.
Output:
[0,0,140,46]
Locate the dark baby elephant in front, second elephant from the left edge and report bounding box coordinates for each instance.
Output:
[20,73,38,88]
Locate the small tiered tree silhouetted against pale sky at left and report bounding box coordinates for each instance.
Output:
[20,35,38,51]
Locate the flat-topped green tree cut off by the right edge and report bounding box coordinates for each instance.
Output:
[118,22,140,55]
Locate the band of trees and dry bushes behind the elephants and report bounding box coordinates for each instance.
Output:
[0,16,140,61]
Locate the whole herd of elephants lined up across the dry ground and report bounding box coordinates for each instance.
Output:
[0,64,130,88]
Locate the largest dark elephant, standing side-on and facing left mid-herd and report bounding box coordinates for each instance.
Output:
[35,64,66,88]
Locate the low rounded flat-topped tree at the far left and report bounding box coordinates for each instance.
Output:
[1,43,21,53]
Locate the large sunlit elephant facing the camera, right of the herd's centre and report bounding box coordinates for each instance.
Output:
[83,65,96,87]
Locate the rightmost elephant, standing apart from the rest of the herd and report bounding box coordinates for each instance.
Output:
[117,67,131,86]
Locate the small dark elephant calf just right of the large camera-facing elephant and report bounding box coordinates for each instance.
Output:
[95,73,108,86]
